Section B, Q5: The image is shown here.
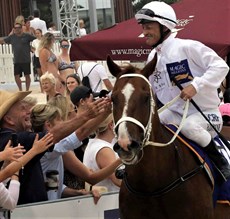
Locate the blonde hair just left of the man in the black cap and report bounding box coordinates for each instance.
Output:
[48,95,70,120]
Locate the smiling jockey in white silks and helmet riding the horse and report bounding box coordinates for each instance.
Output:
[135,1,230,181]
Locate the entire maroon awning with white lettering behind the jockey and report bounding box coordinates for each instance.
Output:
[70,0,230,61]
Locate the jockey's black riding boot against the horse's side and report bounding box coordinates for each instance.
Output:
[204,140,230,181]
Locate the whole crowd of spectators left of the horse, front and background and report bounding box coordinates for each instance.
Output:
[0,7,118,217]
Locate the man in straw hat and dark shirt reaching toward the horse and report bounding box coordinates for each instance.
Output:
[0,90,110,204]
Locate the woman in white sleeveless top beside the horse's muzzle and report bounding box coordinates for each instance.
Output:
[83,114,121,191]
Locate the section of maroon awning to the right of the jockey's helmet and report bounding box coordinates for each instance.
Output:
[172,0,230,57]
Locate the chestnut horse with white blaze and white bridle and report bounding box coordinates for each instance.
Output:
[107,57,230,219]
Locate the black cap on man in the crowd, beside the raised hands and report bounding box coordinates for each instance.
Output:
[70,85,99,105]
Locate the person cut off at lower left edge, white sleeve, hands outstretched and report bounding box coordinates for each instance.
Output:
[0,134,53,219]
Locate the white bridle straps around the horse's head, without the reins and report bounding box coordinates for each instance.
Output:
[114,73,155,148]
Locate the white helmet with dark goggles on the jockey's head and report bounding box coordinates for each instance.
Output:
[135,1,177,30]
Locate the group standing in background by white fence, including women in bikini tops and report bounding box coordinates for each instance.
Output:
[0,9,89,93]
